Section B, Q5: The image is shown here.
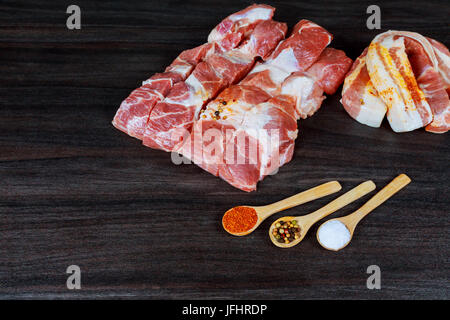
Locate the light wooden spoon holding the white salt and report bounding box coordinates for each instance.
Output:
[316,174,411,251]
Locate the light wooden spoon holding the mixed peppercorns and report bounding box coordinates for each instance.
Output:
[269,180,375,248]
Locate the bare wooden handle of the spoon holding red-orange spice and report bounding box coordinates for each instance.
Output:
[259,181,342,220]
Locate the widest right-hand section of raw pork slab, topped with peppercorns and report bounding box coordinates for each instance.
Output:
[178,20,352,191]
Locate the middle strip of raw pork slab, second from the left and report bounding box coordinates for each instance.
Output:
[143,20,287,151]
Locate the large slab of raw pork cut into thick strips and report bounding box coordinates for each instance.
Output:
[113,5,352,191]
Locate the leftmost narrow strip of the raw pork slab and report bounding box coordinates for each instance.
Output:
[112,4,275,139]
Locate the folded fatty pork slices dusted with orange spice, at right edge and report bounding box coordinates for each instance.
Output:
[341,31,450,133]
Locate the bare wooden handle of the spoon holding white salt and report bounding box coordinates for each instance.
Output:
[349,174,411,229]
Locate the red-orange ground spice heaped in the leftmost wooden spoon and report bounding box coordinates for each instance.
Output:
[222,206,258,233]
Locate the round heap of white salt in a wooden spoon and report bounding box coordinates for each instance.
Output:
[318,220,351,250]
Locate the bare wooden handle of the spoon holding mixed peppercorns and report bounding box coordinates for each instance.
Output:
[303,180,376,226]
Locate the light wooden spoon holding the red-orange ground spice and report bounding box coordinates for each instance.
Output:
[222,181,342,236]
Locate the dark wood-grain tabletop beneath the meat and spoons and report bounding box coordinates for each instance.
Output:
[0,0,450,299]
